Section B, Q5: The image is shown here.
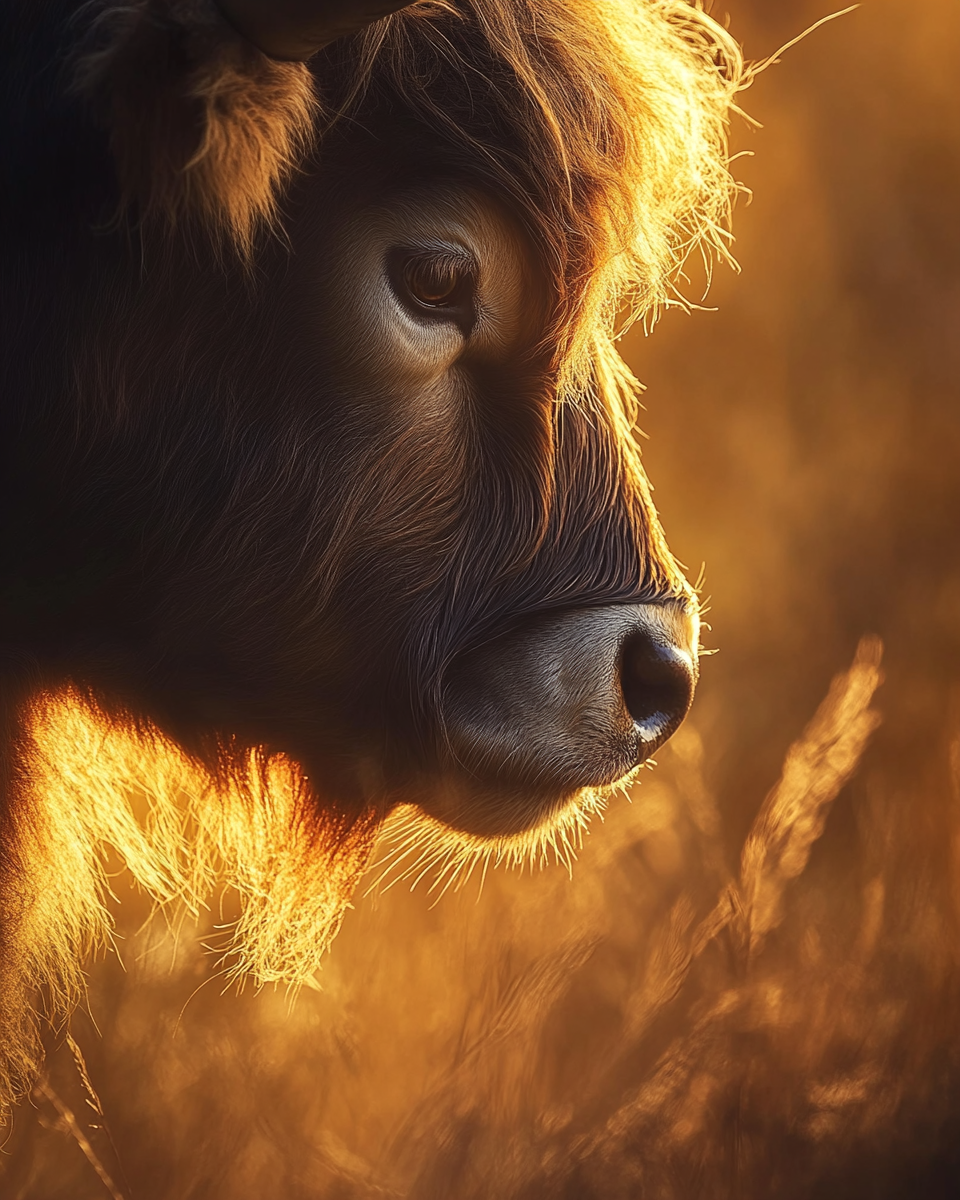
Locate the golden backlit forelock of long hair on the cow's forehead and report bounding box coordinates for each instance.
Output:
[316,0,745,398]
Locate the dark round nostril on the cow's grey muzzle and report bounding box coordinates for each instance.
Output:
[620,631,695,757]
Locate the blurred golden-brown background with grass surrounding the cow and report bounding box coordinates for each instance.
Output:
[0,0,960,1200]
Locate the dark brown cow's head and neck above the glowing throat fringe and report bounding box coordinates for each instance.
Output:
[0,0,739,1104]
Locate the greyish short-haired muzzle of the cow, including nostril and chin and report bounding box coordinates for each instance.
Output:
[431,601,700,833]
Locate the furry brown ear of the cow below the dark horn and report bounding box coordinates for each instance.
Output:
[74,0,318,258]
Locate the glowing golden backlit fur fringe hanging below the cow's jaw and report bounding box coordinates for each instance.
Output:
[0,690,377,1098]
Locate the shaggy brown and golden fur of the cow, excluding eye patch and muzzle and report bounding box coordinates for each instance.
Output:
[0,0,742,1113]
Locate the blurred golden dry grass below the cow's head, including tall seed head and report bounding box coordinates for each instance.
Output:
[5,640,960,1200]
